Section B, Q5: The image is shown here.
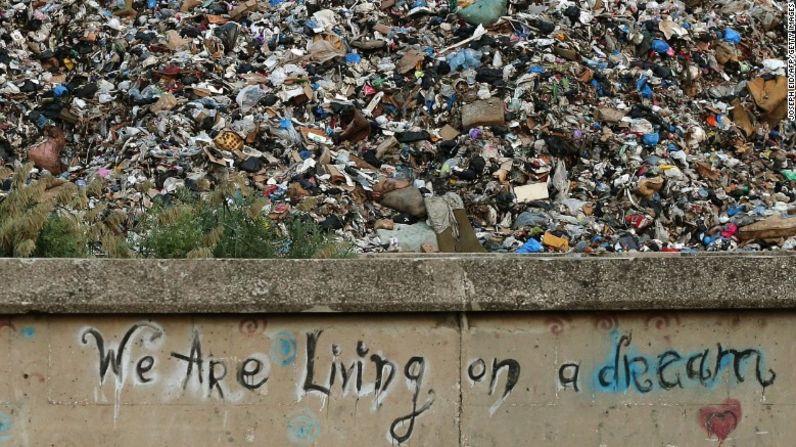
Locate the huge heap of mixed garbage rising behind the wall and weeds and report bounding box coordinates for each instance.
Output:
[0,0,796,253]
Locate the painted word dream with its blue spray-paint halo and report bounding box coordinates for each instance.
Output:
[591,329,776,394]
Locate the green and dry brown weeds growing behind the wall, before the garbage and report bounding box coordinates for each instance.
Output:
[0,165,349,258]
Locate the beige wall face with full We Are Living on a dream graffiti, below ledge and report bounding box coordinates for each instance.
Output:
[0,310,796,447]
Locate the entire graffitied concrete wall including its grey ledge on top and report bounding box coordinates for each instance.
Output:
[0,256,796,447]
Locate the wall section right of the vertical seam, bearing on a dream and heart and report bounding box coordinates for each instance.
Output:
[460,311,784,447]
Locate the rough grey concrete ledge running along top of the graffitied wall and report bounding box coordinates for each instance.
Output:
[0,253,796,314]
